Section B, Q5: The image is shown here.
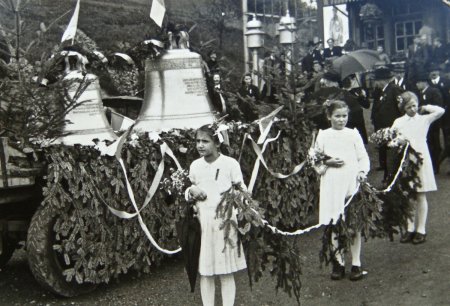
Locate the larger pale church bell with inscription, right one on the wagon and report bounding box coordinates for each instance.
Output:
[134,46,214,131]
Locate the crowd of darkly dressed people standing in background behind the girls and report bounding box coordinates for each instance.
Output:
[205,32,450,178]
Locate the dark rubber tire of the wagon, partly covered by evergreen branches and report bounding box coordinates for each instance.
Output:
[26,206,97,297]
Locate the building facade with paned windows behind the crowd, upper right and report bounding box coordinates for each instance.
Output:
[317,0,450,56]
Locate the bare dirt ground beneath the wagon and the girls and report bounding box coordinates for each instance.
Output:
[0,118,450,306]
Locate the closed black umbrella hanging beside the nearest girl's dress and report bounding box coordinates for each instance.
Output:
[176,204,202,292]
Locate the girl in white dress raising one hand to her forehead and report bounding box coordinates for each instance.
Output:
[392,91,445,244]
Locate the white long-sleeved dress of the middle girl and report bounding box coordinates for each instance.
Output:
[315,128,370,224]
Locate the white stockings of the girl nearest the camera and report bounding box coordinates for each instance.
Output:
[200,274,236,306]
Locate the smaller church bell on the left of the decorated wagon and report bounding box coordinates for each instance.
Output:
[55,51,117,145]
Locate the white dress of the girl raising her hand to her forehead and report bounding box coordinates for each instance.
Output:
[392,105,445,192]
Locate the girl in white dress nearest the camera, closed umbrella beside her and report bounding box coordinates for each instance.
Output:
[187,125,247,306]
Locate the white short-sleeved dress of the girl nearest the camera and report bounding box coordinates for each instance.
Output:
[189,154,247,276]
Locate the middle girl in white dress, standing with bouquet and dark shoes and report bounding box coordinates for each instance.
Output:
[315,100,370,280]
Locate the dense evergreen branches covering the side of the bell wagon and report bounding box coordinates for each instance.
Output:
[42,117,317,306]
